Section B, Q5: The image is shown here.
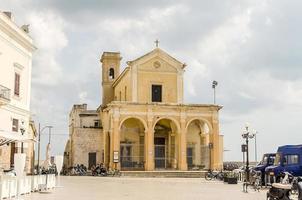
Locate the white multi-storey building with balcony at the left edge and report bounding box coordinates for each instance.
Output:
[0,11,36,169]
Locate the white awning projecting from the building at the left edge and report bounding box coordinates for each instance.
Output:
[0,130,36,146]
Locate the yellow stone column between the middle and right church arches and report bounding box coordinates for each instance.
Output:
[178,119,188,171]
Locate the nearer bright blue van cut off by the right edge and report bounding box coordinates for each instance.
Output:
[265,145,302,182]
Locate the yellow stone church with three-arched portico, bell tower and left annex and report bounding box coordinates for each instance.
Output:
[65,48,223,171]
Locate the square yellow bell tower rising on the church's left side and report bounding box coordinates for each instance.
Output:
[101,52,122,105]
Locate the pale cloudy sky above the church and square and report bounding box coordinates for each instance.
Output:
[0,0,302,160]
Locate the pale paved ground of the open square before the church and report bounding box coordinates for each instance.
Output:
[23,177,266,200]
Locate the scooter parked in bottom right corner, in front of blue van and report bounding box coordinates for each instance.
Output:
[266,172,302,200]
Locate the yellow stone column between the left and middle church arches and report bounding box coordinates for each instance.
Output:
[145,120,154,171]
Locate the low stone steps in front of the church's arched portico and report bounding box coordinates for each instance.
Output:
[121,170,207,178]
